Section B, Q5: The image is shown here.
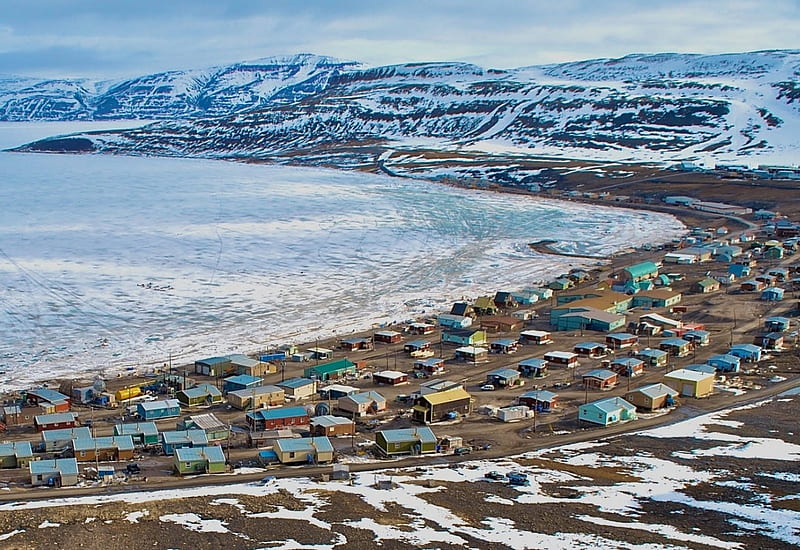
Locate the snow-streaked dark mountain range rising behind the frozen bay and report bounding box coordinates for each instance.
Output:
[6,50,800,175]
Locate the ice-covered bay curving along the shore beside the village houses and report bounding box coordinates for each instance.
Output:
[0,144,684,389]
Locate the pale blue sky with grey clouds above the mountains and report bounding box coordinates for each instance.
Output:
[0,0,800,78]
